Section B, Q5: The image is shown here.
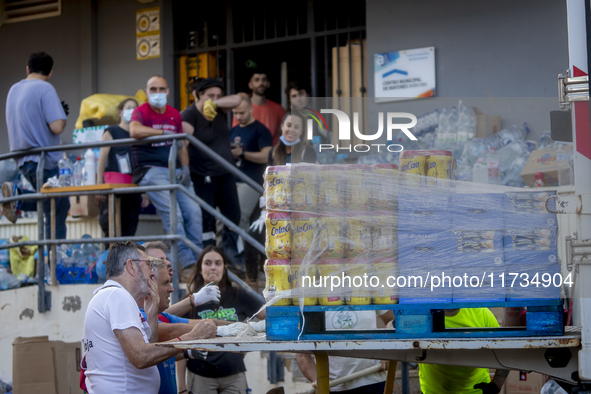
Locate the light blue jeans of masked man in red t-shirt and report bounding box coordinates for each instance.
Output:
[139,167,203,268]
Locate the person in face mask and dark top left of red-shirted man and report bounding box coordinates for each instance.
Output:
[96,98,142,237]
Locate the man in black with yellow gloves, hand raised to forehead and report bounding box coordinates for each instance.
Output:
[181,78,244,276]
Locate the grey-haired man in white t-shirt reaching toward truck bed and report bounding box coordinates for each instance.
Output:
[82,242,217,394]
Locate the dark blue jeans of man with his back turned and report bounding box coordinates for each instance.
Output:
[20,161,70,239]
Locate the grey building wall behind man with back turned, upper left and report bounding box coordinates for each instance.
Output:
[0,0,175,153]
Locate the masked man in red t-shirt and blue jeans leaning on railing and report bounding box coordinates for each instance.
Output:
[129,75,203,270]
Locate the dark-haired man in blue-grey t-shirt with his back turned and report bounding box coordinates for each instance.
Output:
[2,52,70,239]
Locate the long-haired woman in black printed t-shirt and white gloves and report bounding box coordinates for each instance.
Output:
[177,245,265,394]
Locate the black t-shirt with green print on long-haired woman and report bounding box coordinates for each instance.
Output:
[185,287,263,378]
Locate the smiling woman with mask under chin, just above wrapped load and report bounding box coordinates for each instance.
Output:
[267,111,316,166]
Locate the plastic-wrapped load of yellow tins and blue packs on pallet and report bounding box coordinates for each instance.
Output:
[264,156,570,305]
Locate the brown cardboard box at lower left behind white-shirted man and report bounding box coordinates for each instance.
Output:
[12,336,82,394]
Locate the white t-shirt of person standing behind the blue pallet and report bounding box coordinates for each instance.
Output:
[325,311,386,391]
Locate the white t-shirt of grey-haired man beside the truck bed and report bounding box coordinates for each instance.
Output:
[82,280,160,394]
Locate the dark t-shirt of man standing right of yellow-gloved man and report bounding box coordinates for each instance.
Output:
[230,120,273,186]
